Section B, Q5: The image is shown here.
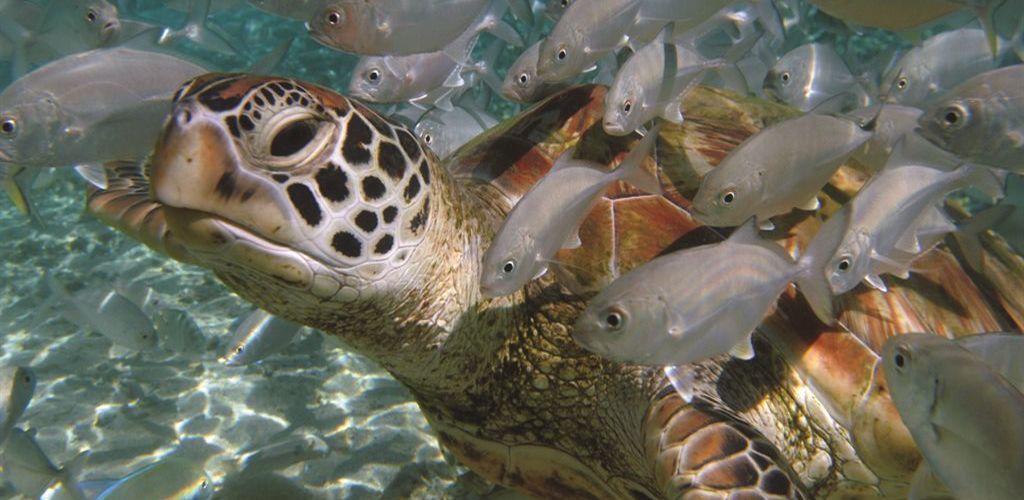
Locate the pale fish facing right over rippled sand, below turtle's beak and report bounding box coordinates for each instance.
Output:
[47,276,157,350]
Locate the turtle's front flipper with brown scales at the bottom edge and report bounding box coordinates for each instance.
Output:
[644,385,810,499]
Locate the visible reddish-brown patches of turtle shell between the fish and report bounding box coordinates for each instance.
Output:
[447,86,1024,488]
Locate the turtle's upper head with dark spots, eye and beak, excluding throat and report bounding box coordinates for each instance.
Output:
[153,75,435,293]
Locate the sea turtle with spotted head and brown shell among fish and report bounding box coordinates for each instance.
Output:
[88,75,1024,499]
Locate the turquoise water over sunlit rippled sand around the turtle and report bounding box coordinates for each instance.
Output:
[0,0,1024,498]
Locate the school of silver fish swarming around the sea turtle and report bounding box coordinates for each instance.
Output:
[0,0,1024,499]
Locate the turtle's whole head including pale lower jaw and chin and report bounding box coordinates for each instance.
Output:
[150,74,444,354]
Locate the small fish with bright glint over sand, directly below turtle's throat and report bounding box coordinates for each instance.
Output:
[220,309,302,366]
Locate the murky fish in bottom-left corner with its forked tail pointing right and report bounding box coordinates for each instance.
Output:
[3,427,88,499]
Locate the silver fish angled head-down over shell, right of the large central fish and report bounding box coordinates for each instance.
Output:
[807,157,1001,295]
